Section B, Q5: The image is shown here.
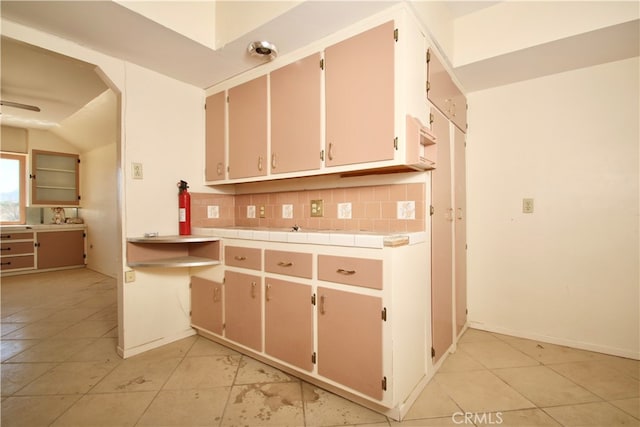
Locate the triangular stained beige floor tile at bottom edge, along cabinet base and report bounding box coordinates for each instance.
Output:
[302,383,387,427]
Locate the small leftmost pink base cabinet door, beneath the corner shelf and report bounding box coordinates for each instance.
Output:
[191,276,222,335]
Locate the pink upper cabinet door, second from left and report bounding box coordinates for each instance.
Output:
[229,76,269,179]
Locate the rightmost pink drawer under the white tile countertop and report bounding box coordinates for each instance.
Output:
[318,255,382,289]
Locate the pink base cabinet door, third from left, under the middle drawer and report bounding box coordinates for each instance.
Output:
[264,277,313,372]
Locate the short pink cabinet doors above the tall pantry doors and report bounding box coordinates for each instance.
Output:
[427,49,467,133]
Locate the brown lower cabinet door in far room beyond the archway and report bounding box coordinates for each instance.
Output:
[36,230,84,268]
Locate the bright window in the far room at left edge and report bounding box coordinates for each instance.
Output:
[0,153,26,224]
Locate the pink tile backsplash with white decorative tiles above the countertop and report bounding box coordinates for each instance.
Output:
[191,183,426,233]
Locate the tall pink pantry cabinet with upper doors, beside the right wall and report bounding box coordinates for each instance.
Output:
[427,50,467,363]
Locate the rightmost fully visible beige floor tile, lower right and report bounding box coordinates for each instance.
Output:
[492,366,601,406]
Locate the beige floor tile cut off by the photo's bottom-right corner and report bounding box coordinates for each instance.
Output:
[543,402,640,427]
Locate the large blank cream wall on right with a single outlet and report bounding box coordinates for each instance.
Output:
[467,57,640,358]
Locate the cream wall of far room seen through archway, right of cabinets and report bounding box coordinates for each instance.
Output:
[80,142,121,277]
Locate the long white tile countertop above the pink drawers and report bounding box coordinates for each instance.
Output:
[191,227,427,249]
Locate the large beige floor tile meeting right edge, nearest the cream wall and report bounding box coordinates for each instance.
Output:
[548,360,640,400]
